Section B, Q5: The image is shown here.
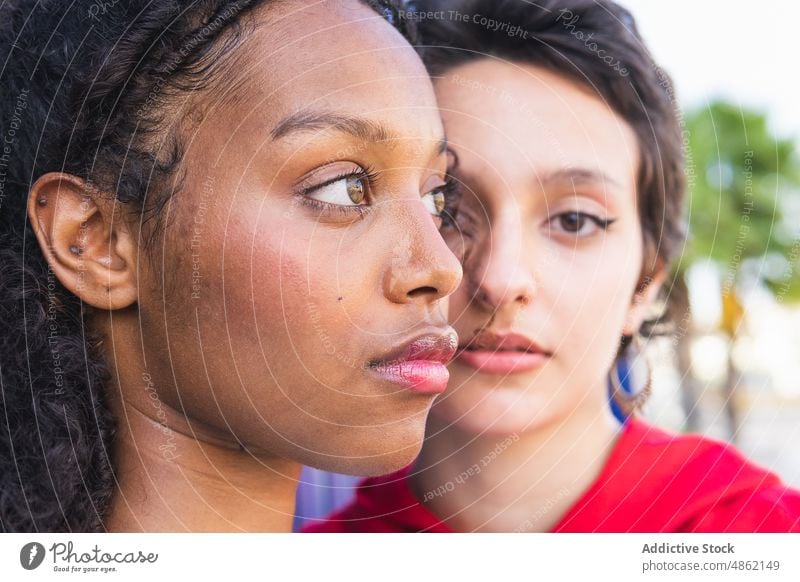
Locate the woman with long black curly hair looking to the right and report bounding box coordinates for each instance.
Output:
[0,0,460,531]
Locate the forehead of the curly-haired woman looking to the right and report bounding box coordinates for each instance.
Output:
[231,0,442,136]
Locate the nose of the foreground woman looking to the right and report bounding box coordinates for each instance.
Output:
[384,201,462,303]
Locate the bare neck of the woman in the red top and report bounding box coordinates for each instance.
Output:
[411,399,620,532]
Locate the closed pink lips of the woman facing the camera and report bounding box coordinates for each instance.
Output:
[457,332,552,375]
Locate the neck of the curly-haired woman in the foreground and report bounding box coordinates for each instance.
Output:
[105,384,300,532]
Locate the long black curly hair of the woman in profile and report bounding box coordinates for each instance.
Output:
[0,0,413,532]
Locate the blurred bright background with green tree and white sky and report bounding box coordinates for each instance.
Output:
[621,0,800,486]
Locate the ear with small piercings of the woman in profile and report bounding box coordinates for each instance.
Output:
[28,172,137,310]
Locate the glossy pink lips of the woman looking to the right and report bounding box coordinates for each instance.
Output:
[370,333,458,394]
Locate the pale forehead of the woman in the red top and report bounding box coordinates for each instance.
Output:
[436,59,639,187]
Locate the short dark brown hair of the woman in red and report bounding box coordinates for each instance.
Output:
[405,0,686,413]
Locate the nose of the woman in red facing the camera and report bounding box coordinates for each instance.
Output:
[464,217,536,313]
